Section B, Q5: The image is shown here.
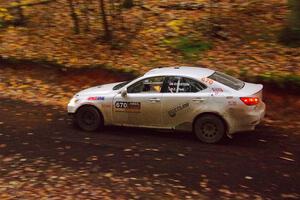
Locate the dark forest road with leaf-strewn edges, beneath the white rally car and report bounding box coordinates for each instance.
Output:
[0,63,300,200]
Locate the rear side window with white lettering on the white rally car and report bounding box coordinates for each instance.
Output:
[164,77,206,93]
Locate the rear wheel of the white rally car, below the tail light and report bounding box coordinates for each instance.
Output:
[194,114,226,144]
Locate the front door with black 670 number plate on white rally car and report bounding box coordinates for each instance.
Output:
[113,76,164,127]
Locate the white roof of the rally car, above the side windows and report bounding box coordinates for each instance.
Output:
[143,66,215,79]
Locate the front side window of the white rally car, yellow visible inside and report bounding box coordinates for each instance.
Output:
[127,77,164,93]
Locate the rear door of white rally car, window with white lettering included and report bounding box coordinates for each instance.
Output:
[162,76,209,129]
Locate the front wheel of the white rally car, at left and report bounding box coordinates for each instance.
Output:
[75,106,103,132]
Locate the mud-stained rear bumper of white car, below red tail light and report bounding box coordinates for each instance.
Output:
[228,103,266,135]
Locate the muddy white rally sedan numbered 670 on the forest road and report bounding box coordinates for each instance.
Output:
[68,67,265,143]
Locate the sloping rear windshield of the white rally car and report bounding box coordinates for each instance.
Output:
[208,72,245,90]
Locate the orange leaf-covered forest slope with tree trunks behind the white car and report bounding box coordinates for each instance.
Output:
[0,0,300,82]
